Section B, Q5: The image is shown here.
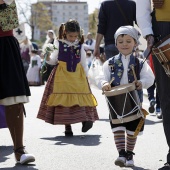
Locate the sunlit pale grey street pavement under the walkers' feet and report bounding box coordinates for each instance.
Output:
[0,86,168,170]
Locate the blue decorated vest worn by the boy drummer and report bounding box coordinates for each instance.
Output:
[109,54,143,102]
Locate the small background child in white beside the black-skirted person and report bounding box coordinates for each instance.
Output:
[27,50,41,86]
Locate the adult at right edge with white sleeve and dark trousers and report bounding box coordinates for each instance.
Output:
[136,0,170,170]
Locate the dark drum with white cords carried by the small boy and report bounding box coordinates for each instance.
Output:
[104,83,144,124]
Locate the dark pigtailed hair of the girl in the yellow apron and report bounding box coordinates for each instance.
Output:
[59,19,84,44]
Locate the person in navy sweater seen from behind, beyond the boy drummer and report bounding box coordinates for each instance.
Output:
[94,0,136,59]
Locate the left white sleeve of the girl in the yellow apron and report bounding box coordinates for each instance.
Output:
[46,40,59,65]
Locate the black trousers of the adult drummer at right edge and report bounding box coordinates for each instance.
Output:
[153,22,170,163]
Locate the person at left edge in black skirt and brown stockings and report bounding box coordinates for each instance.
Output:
[0,0,35,164]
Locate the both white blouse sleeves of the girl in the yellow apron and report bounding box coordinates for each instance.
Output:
[46,40,88,76]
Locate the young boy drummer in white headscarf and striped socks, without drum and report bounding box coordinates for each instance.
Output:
[99,26,154,166]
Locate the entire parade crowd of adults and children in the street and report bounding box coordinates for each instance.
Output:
[0,0,170,170]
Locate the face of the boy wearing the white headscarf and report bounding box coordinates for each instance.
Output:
[116,35,137,56]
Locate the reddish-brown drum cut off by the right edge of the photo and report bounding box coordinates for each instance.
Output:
[152,35,170,77]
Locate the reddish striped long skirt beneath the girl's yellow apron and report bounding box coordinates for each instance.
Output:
[37,66,99,125]
